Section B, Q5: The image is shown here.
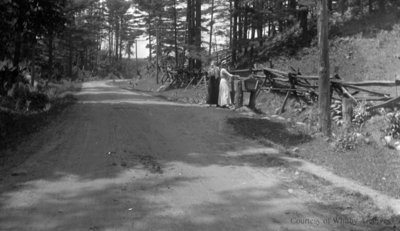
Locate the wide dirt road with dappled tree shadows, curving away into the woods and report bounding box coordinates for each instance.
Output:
[0,82,378,231]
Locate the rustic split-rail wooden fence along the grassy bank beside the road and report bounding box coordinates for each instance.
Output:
[232,67,400,111]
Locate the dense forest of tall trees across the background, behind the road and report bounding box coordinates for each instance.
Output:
[0,0,399,96]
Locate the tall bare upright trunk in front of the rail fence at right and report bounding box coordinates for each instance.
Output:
[318,0,331,136]
